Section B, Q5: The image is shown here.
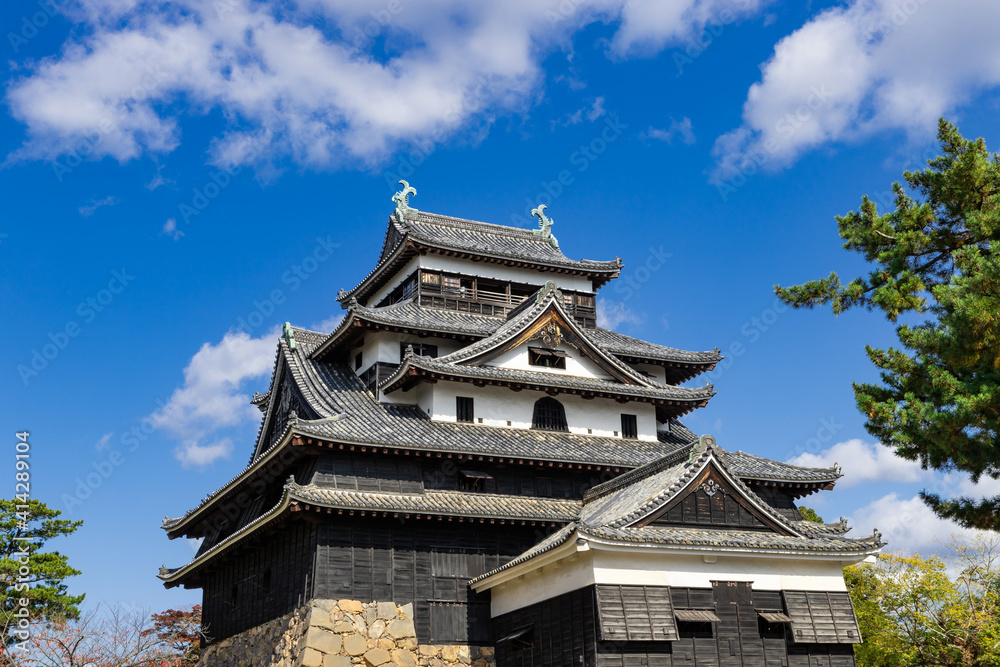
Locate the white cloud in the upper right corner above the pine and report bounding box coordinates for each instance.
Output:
[714,0,1000,179]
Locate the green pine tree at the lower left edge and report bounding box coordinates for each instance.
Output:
[0,499,84,644]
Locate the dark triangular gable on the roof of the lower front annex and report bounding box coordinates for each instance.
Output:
[635,463,787,533]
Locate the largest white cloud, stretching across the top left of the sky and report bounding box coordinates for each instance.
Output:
[6,0,760,168]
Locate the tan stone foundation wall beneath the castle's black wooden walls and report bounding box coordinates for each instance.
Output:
[198,600,496,667]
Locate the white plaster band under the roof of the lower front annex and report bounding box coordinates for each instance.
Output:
[490,549,850,617]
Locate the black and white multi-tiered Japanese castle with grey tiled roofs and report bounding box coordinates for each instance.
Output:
[159,182,883,667]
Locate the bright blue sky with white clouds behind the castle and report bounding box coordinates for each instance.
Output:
[0,0,1000,610]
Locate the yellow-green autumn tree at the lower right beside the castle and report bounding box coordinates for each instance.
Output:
[844,537,1000,667]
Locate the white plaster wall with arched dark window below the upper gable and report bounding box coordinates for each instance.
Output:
[422,381,656,440]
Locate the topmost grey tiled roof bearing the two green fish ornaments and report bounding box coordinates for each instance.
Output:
[337,211,622,303]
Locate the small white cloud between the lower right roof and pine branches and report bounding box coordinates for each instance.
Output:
[848,493,973,554]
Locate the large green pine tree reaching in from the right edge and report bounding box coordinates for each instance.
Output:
[775,119,1000,530]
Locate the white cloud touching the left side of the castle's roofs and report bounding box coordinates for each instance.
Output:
[151,328,278,466]
